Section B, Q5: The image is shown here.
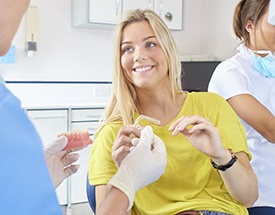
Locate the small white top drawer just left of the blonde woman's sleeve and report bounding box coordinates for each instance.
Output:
[71,107,104,121]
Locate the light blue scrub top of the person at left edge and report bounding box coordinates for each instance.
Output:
[0,84,62,215]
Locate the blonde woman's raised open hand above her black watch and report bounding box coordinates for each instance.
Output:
[169,115,228,159]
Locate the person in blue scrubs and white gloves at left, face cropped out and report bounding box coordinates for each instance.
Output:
[0,0,166,215]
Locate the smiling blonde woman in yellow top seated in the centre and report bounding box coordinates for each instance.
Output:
[89,10,258,215]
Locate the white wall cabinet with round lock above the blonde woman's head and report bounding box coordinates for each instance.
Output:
[71,0,183,30]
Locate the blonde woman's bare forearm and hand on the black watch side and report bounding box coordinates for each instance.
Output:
[169,115,258,207]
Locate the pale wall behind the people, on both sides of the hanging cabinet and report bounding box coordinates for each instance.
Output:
[0,0,242,81]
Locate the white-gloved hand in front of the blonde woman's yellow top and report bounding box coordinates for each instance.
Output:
[108,126,167,210]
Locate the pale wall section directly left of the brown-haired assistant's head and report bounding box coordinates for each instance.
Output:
[202,0,240,59]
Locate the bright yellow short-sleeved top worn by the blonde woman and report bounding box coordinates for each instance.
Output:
[89,92,251,215]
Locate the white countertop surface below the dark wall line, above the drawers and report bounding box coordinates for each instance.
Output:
[6,82,111,109]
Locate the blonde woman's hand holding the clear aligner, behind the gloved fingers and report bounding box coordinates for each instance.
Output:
[112,125,140,168]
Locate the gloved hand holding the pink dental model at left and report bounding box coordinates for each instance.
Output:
[44,136,79,188]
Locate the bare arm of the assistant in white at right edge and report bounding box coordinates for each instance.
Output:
[227,94,275,143]
